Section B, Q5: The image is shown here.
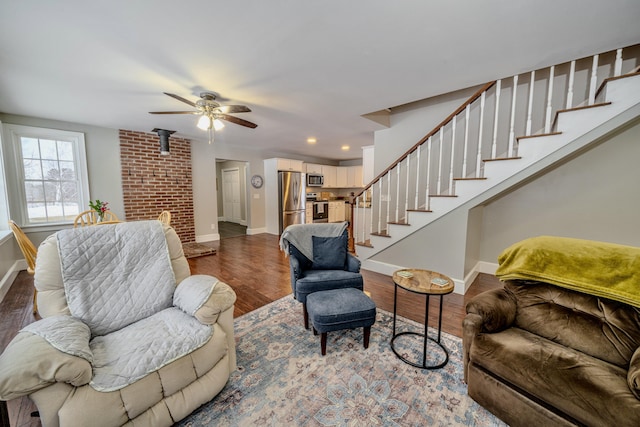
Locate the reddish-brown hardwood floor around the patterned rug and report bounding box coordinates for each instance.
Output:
[0,234,502,426]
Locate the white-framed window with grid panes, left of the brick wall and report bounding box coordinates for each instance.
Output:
[5,125,89,226]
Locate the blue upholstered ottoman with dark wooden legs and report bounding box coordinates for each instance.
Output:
[307,288,376,356]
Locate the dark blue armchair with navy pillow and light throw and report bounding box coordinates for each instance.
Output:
[282,223,364,329]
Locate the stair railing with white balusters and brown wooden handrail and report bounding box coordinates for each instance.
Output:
[350,45,640,251]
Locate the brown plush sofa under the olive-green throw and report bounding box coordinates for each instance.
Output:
[463,237,640,427]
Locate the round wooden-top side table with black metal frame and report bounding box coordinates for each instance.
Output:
[391,269,454,369]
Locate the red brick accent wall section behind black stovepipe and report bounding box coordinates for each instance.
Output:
[120,130,195,243]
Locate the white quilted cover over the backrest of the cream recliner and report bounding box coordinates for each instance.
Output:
[57,221,176,336]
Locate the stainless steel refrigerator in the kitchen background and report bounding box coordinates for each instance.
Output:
[278,172,307,234]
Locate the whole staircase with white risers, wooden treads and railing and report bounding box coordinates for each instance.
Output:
[352,45,640,293]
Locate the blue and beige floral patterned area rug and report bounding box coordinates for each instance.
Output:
[177,296,505,427]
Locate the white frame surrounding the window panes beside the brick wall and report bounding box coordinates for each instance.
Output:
[3,124,90,228]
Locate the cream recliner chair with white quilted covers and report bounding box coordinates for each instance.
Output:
[0,221,236,427]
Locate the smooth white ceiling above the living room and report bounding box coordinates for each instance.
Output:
[0,0,640,160]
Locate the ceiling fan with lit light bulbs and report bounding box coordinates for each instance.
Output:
[149,92,258,143]
